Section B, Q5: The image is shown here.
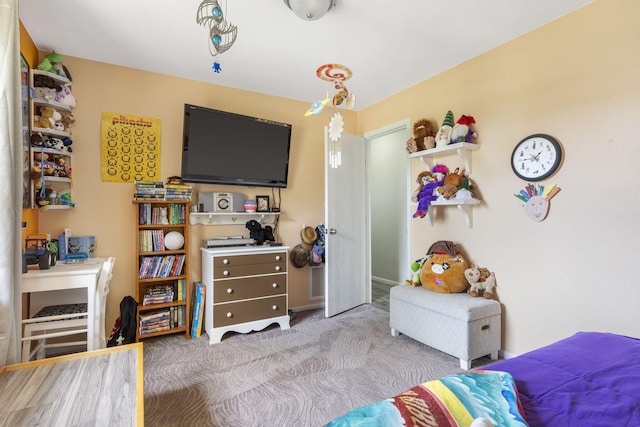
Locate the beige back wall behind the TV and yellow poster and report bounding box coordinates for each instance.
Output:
[33,56,356,338]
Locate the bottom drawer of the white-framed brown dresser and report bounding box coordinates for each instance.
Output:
[213,295,287,328]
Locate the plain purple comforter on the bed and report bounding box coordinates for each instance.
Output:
[483,332,640,427]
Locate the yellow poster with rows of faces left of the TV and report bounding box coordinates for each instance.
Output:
[100,113,162,183]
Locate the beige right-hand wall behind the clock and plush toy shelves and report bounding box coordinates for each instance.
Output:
[358,0,640,354]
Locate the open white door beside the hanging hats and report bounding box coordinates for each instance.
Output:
[324,129,364,317]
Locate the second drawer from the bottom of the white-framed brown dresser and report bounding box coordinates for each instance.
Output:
[213,274,287,304]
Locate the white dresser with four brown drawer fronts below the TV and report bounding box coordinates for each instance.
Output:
[201,246,289,344]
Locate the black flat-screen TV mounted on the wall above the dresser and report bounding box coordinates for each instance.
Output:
[181,104,291,188]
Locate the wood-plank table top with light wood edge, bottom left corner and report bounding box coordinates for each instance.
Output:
[0,343,144,426]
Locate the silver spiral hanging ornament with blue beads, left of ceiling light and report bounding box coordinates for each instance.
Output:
[196,0,238,73]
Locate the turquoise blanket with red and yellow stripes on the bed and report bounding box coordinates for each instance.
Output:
[327,370,528,427]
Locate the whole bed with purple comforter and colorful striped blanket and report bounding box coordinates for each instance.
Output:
[328,332,640,427]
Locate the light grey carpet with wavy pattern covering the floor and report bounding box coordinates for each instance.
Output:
[144,305,460,427]
